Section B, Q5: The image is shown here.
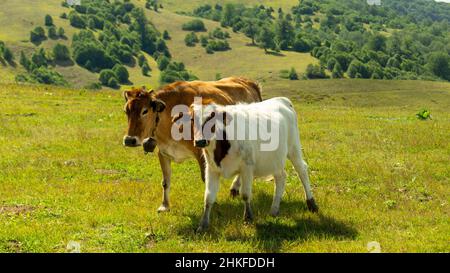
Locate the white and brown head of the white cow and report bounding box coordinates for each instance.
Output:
[178,101,232,148]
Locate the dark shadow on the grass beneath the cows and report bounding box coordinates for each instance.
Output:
[178,190,357,252]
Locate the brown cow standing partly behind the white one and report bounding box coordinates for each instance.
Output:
[123,77,262,212]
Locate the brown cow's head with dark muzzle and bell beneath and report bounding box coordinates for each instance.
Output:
[123,87,166,152]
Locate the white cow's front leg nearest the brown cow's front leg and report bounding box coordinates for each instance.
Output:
[197,168,220,232]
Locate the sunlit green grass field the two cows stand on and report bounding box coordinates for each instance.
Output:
[0,80,450,252]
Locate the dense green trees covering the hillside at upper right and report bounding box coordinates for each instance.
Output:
[187,0,450,79]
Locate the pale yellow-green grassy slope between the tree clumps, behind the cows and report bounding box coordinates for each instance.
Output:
[148,10,318,80]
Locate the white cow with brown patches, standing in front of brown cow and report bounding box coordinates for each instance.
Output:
[190,98,318,231]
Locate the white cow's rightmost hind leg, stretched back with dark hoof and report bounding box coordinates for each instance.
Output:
[289,148,319,212]
